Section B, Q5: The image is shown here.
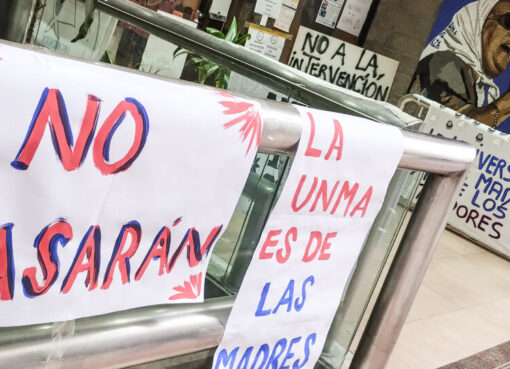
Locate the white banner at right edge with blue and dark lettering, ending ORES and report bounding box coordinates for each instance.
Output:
[423,103,510,257]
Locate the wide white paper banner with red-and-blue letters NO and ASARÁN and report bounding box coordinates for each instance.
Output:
[0,45,262,326]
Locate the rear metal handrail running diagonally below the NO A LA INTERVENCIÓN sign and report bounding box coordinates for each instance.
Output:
[96,0,404,127]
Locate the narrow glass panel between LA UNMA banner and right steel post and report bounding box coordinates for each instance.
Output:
[321,169,421,368]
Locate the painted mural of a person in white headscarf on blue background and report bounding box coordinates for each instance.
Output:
[410,0,510,133]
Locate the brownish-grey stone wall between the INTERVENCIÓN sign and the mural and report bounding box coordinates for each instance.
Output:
[363,0,442,104]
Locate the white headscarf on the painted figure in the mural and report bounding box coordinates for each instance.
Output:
[421,0,499,107]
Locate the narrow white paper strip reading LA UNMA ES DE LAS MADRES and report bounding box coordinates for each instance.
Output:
[213,108,403,369]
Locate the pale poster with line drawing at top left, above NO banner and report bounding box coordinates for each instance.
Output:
[33,0,117,60]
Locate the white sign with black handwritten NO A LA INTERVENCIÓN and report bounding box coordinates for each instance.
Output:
[289,27,398,101]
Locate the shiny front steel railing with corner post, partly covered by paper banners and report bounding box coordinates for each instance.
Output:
[0,44,475,369]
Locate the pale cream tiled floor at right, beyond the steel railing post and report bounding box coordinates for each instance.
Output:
[386,231,510,369]
